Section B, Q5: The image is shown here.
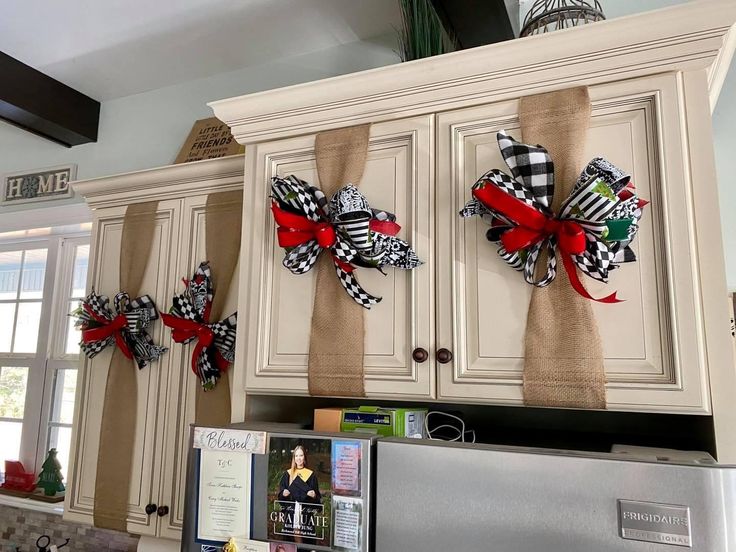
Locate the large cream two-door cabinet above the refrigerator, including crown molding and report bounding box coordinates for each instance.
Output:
[211,0,736,460]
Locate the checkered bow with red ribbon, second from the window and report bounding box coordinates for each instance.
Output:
[161,261,238,390]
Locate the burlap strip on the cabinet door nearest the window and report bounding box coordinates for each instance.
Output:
[94,201,158,531]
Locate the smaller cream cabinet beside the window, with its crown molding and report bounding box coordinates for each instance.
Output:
[64,156,243,539]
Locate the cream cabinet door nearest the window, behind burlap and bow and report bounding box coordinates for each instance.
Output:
[64,200,180,535]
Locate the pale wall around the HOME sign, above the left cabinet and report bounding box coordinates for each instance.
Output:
[0,35,398,216]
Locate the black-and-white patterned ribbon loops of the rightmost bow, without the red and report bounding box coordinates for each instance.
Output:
[460,131,646,287]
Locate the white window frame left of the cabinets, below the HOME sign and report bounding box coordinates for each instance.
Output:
[0,229,91,473]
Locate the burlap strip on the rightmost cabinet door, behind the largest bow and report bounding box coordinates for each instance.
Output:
[519,87,606,408]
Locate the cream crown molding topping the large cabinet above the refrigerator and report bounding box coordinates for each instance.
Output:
[208,0,736,144]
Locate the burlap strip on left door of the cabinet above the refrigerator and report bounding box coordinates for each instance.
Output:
[309,125,370,397]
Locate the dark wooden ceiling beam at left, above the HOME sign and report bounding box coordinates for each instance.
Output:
[0,52,100,147]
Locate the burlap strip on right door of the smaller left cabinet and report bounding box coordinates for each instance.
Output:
[194,190,243,426]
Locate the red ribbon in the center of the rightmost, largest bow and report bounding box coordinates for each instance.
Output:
[473,183,621,303]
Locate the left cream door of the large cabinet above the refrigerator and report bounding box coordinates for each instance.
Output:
[240,116,434,398]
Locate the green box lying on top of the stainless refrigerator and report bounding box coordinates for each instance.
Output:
[340,406,427,438]
